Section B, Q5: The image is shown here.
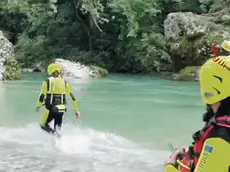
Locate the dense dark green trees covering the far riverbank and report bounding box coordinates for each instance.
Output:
[0,0,226,73]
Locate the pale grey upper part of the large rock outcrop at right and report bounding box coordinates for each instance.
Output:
[164,11,230,39]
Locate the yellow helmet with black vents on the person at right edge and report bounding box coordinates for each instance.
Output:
[199,56,230,104]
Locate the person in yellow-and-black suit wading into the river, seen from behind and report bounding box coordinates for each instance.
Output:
[36,63,80,136]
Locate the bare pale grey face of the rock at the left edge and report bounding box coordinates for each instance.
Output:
[0,30,14,80]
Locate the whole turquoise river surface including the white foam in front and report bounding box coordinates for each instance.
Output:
[0,73,204,172]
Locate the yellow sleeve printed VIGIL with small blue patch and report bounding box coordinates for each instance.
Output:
[194,138,230,172]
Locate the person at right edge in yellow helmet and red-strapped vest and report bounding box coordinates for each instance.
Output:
[164,56,230,172]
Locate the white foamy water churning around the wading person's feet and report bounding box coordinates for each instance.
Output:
[0,124,169,172]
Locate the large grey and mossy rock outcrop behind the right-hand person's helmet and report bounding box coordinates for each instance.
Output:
[164,10,230,81]
